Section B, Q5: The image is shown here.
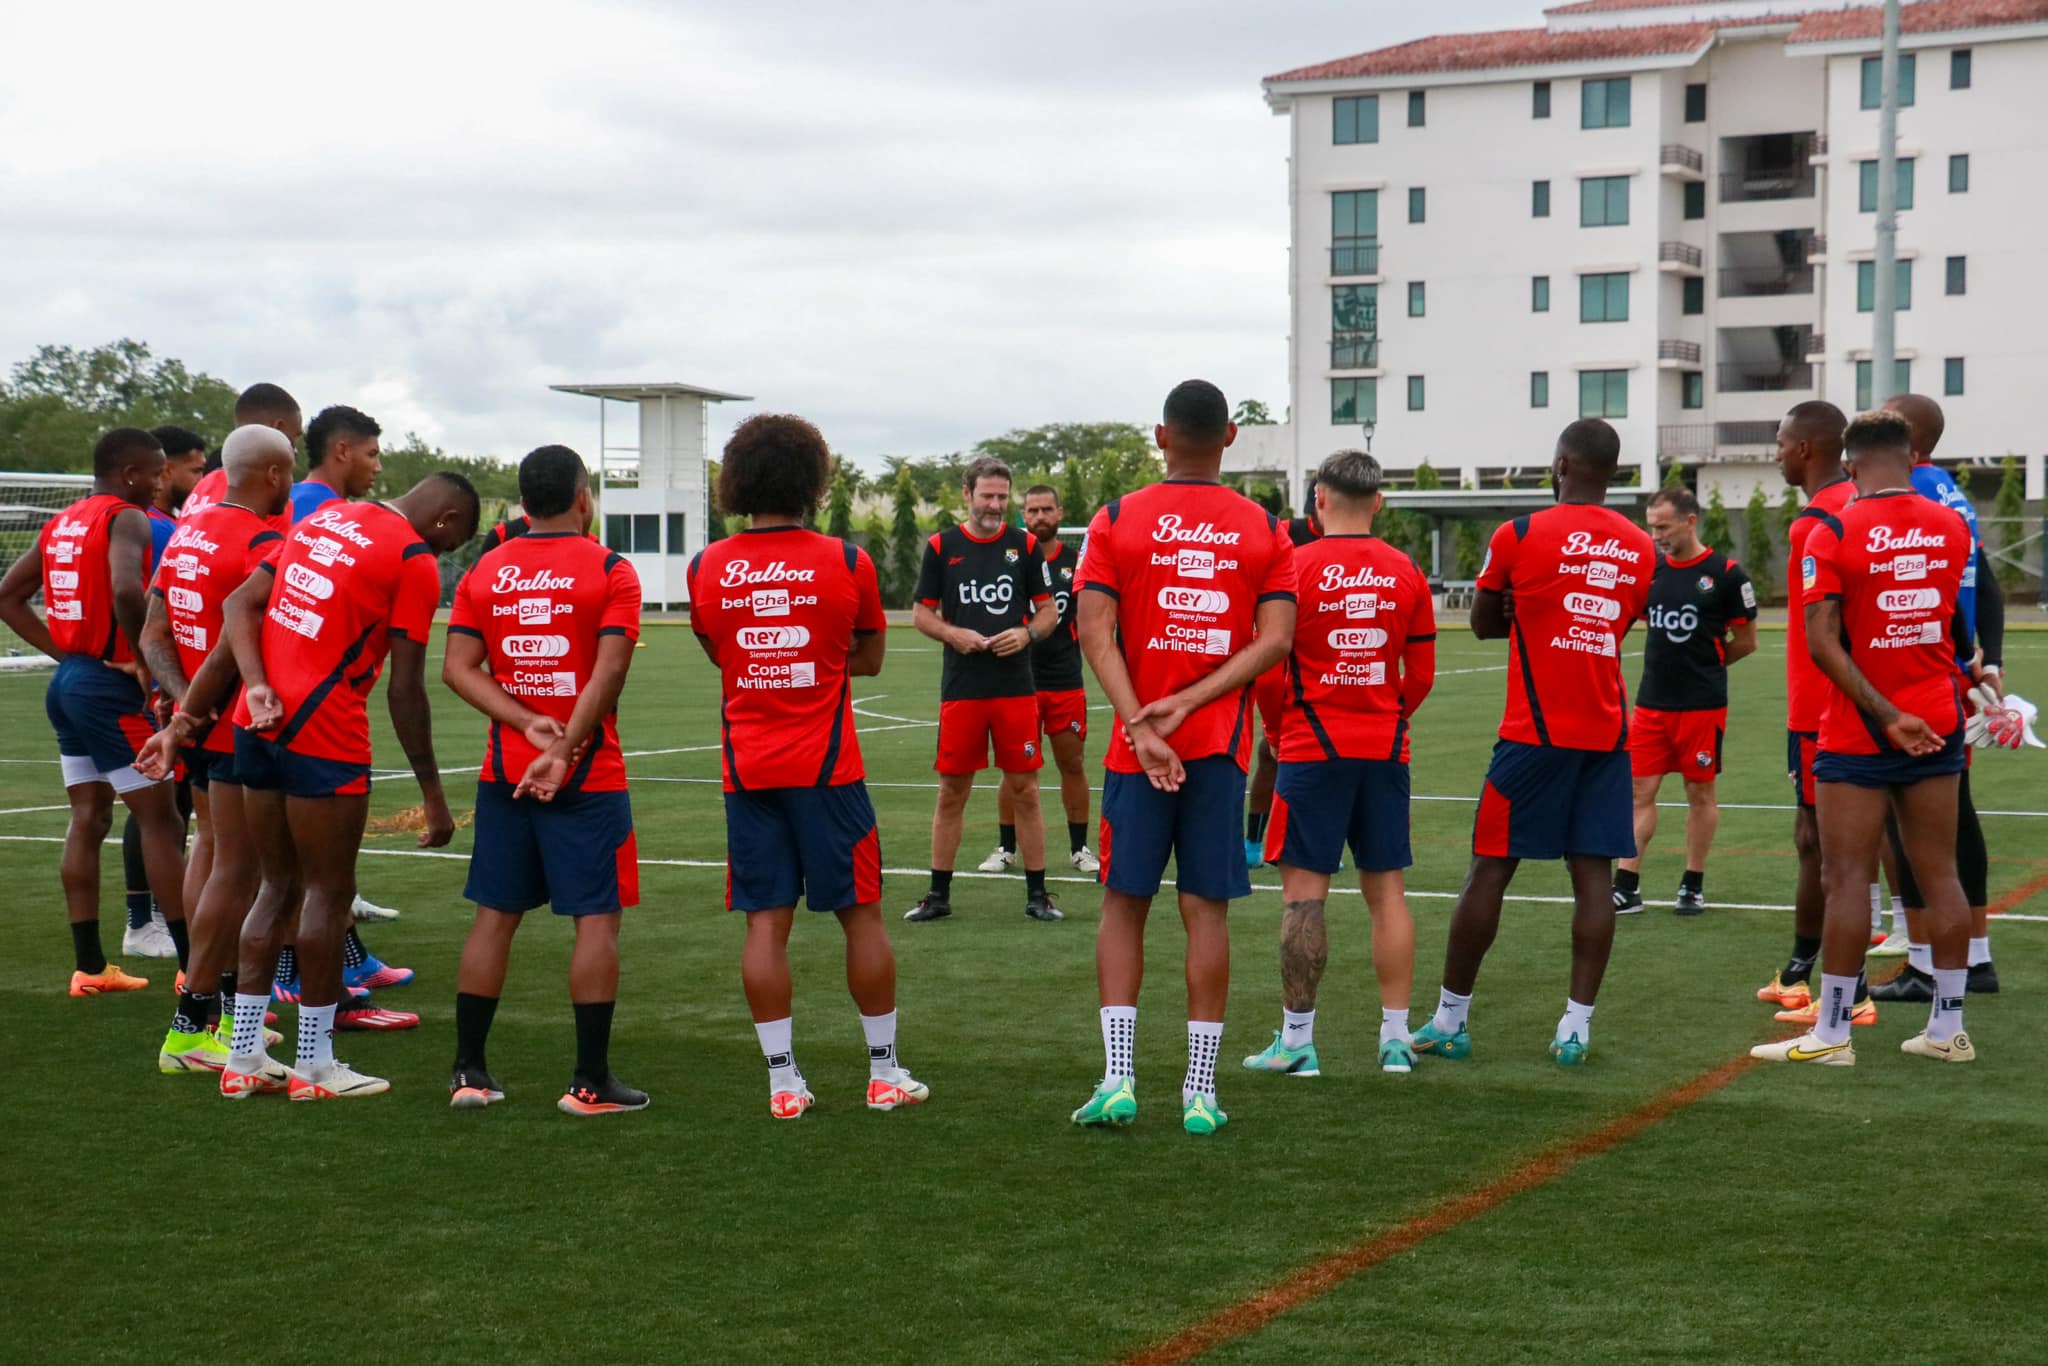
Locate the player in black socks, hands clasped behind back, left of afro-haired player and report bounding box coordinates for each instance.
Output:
[440,446,647,1116]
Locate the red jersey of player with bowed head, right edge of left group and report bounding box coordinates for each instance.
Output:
[233,502,440,764]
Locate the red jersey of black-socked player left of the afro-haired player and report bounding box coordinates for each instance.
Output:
[449,532,641,793]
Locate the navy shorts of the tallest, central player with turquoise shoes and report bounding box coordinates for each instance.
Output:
[1096,754,1251,901]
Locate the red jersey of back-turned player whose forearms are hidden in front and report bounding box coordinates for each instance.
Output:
[1479,504,1657,752]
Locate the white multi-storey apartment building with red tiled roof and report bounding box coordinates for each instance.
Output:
[1233,0,2048,508]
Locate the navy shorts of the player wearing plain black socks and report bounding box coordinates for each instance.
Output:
[463,782,639,915]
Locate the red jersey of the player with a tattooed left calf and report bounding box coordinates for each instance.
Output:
[1280,535,1436,764]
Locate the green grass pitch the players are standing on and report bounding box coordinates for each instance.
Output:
[0,627,2048,1366]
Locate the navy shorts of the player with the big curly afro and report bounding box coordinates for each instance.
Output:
[725,782,883,911]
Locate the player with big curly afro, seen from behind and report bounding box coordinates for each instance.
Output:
[690,414,930,1120]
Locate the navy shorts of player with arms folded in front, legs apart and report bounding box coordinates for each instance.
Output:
[1473,739,1636,858]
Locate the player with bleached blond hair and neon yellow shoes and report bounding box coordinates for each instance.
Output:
[141,424,293,1073]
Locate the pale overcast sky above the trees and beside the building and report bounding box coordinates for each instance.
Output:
[0,0,1540,471]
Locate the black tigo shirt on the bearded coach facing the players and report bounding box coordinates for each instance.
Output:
[918,526,1053,702]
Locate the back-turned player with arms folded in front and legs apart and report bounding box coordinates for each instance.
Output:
[1415,418,1657,1067]
